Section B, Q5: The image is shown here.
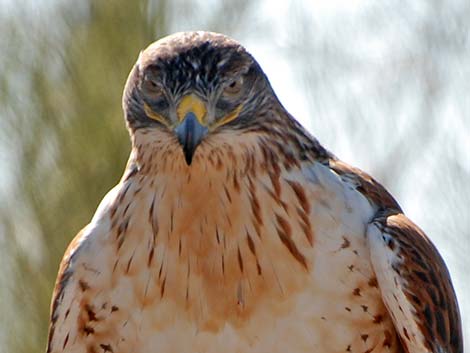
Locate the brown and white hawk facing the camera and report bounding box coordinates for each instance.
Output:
[47,32,463,353]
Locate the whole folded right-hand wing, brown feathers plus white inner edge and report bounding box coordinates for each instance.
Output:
[367,211,463,353]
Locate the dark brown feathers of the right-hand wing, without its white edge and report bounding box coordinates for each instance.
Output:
[373,212,463,353]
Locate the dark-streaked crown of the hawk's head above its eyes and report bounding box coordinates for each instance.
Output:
[138,32,253,93]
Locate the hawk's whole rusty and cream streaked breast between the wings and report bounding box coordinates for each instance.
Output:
[67,135,397,352]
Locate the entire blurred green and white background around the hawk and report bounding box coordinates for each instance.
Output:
[0,0,470,353]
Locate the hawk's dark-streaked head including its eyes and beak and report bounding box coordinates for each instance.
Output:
[123,32,277,165]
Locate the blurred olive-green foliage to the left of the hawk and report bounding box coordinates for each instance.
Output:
[2,1,158,352]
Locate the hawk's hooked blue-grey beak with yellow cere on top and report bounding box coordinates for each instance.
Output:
[175,95,209,166]
